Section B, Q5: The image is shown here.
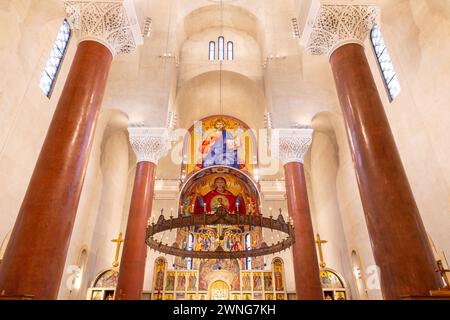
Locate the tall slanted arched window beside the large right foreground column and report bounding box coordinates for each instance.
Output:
[370,25,401,102]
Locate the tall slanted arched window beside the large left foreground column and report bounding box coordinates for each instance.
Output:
[39,20,72,98]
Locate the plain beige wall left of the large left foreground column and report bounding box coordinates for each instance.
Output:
[0,0,76,252]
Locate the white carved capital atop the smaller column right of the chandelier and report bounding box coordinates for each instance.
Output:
[272,128,313,165]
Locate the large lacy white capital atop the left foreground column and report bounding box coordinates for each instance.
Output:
[64,0,144,56]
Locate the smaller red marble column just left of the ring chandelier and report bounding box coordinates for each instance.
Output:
[115,161,156,300]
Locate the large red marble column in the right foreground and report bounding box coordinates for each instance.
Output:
[330,44,439,299]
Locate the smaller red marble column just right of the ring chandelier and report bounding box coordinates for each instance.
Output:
[284,162,323,300]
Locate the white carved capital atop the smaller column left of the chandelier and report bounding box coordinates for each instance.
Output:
[128,127,169,164]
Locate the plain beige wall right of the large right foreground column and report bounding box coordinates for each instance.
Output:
[367,0,450,256]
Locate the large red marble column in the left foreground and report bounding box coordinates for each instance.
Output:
[0,41,113,299]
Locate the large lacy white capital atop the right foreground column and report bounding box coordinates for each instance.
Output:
[300,0,380,57]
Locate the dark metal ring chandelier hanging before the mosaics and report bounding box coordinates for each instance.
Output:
[146,207,295,259]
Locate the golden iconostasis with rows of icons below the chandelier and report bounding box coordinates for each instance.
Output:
[151,257,287,300]
